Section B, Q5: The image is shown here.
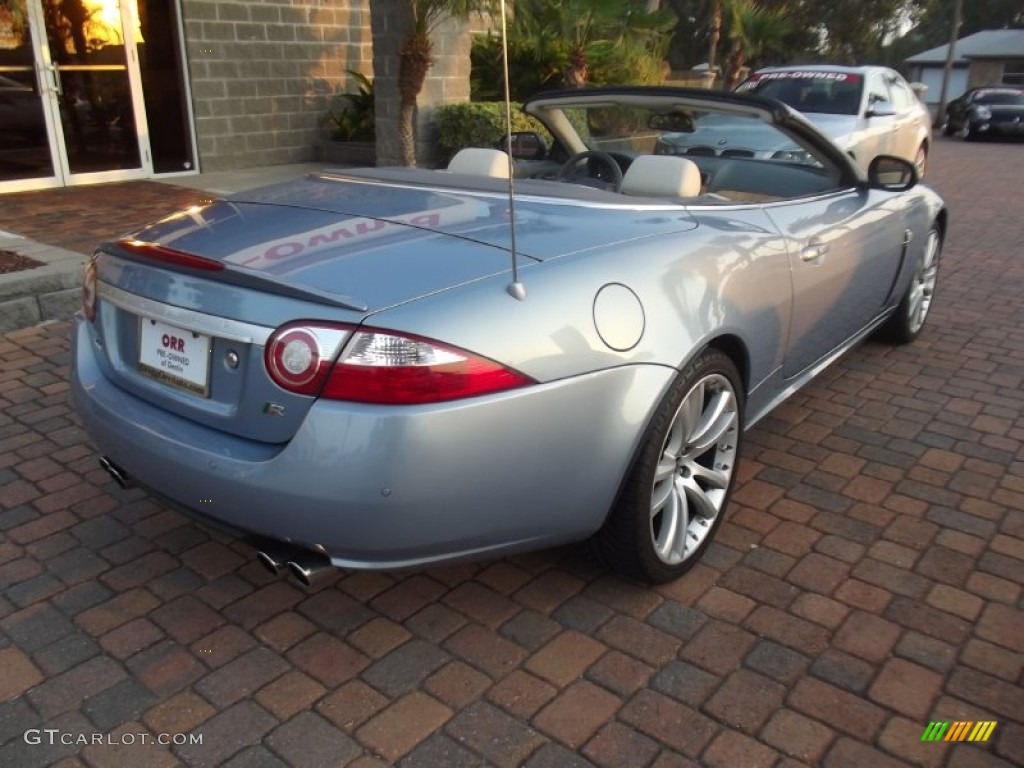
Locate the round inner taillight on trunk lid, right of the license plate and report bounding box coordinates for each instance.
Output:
[263,323,351,394]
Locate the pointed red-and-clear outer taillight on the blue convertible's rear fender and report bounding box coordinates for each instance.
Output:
[321,329,534,406]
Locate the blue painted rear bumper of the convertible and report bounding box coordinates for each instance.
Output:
[71,317,675,568]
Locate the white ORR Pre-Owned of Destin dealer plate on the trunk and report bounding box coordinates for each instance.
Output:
[138,317,210,397]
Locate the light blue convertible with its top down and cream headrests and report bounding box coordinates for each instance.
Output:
[71,87,947,583]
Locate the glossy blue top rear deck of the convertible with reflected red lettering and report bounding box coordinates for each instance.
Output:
[117,172,695,308]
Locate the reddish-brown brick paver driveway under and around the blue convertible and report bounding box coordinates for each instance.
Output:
[0,138,1024,768]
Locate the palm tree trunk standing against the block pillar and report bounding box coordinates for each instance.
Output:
[398,0,493,166]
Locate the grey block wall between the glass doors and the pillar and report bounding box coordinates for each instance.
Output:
[181,0,373,171]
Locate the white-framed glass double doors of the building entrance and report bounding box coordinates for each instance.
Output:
[0,0,152,191]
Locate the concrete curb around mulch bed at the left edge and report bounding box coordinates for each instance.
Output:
[0,232,86,333]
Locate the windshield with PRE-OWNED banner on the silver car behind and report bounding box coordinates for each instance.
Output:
[736,70,864,115]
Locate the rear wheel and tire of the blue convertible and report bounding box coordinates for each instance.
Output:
[593,349,744,584]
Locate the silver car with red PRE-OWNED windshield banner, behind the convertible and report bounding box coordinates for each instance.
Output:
[720,65,932,177]
